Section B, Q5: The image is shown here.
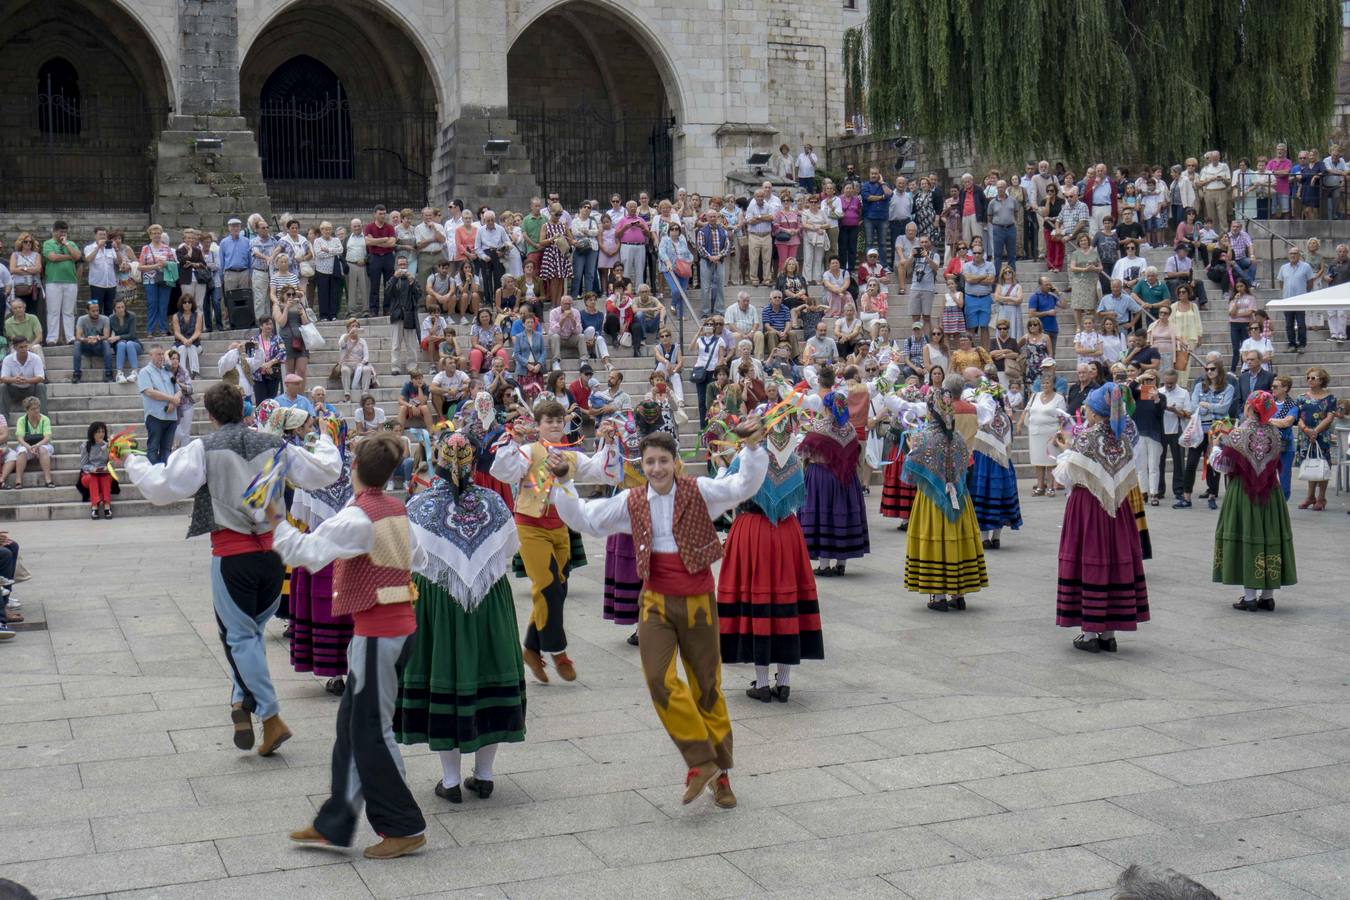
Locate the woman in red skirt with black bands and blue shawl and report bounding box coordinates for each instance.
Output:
[717,416,825,703]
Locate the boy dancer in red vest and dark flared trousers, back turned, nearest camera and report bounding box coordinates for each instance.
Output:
[282,434,427,860]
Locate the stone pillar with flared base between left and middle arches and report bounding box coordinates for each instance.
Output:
[153,0,271,230]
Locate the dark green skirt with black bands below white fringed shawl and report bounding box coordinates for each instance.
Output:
[394,575,525,753]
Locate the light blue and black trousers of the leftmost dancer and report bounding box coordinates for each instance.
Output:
[211,551,286,719]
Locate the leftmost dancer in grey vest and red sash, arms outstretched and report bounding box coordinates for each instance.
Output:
[127,382,342,756]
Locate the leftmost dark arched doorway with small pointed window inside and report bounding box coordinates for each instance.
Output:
[0,0,170,212]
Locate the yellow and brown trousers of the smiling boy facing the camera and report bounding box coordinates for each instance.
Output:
[637,591,732,769]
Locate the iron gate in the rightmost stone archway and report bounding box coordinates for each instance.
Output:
[512,107,675,209]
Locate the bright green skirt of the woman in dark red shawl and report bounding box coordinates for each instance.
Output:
[1214,480,1299,590]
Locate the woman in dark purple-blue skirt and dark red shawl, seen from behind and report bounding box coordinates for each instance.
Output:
[798,391,871,578]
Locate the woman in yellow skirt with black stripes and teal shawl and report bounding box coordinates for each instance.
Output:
[900,389,990,613]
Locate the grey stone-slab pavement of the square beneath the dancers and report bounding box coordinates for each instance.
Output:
[0,486,1350,900]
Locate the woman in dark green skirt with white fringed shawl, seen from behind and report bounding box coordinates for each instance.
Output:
[394,430,525,803]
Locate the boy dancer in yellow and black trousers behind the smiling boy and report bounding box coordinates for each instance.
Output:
[491,399,624,684]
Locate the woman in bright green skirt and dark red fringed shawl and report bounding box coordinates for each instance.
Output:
[1214,390,1299,613]
